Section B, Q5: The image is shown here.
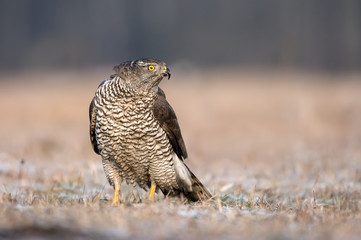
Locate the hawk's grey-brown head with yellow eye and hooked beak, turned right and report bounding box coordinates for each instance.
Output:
[113,58,171,92]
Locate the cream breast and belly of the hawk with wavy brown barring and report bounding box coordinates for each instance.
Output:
[95,89,177,189]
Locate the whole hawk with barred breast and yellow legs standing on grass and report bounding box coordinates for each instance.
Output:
[89,58,212,205]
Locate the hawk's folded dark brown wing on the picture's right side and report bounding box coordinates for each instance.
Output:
[152,88,188,159]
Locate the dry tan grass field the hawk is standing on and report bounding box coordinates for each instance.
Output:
[0,67,361,239]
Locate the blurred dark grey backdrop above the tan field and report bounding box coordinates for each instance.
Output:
[0,0,361,72]
